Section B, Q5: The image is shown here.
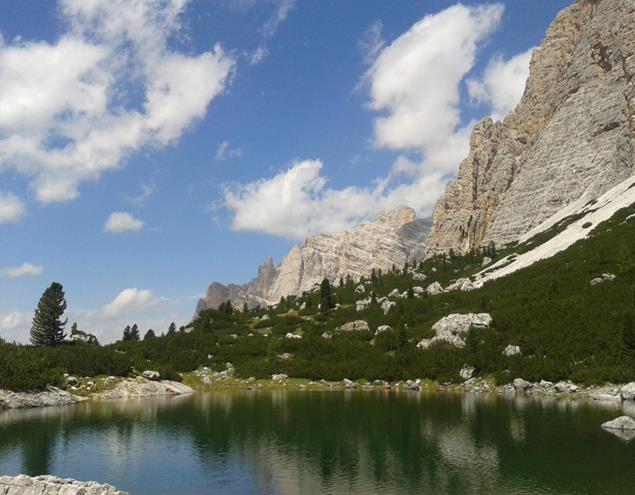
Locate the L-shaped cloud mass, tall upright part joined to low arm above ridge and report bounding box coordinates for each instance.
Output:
[224,4,528,239]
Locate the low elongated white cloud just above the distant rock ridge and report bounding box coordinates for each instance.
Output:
[224,160,443,239]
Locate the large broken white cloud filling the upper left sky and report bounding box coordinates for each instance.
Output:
[0,0,234,205]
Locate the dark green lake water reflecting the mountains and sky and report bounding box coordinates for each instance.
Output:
[0,391,635,495]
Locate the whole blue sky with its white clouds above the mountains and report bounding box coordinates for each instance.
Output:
[0,0,570,342]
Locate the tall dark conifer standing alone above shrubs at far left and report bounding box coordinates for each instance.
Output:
[31,282,68,346]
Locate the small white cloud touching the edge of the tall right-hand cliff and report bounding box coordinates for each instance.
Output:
[467,48,534,120]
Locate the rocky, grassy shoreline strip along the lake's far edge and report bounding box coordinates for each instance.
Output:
[0,371,635,412]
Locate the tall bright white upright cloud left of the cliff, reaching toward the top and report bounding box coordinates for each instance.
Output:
[366,4,504,154]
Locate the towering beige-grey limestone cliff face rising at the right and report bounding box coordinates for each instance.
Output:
[426,0,635,253]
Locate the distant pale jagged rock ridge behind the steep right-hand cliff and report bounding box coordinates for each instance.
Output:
[196,207,431,314]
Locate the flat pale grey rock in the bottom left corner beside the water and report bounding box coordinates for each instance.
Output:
[0,475,127,495]
